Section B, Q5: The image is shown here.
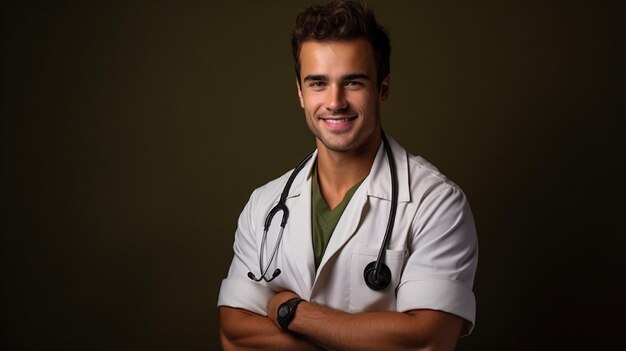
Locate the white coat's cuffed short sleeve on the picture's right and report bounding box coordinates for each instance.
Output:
[397,184,478,335]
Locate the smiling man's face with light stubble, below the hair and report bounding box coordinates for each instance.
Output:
[298,39,388,154]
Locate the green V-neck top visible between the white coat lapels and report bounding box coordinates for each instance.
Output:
[311,165,363,269]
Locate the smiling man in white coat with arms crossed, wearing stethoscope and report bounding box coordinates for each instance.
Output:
[218,1,478,350]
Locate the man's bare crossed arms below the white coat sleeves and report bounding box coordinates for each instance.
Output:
[220,291,464,351]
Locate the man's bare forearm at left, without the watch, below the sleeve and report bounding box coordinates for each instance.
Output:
[220,307,322,351]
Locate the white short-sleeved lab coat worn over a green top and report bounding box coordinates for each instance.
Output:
[218,139,478,333]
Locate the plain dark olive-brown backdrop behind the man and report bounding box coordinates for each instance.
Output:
[1,0,625,350]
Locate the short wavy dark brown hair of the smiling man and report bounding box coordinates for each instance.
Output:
[291,0,391,88]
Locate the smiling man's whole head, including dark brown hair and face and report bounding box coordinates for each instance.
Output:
[292,1,390,155]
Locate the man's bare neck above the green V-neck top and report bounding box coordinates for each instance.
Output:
[317,138,380,209]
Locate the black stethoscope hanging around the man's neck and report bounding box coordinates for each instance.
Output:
[248,132,398,290]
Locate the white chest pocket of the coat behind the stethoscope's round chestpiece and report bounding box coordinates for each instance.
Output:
[348,248,406,313]
